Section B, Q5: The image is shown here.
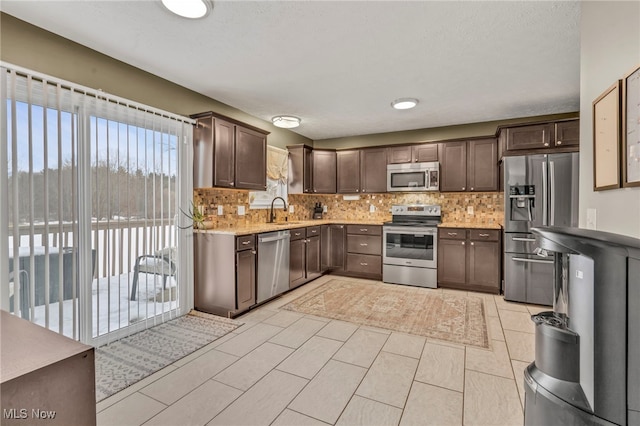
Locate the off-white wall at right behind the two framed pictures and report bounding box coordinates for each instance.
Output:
[580,1,640,238]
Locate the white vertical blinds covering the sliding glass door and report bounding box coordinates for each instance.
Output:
[0,64,193,344]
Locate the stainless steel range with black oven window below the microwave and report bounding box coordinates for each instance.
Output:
[382,204,442,288]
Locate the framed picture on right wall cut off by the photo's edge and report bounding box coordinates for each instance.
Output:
[622,65,640,186]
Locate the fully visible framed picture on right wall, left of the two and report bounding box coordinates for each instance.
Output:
[593,80,620,191]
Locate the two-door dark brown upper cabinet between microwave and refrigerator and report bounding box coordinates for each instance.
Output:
[438,138,498,192]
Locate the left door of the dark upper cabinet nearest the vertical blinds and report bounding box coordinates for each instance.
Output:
[213,118,236,188]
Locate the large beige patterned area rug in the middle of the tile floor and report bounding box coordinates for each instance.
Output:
[282,279,489,348]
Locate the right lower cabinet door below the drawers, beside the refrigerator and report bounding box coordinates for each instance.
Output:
[467,241,500,293]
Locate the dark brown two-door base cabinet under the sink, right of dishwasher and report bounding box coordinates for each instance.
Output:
[289,226,322,288]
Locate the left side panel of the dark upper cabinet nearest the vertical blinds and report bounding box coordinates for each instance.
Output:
[193,117,214,188]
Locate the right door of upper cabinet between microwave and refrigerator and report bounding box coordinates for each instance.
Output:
[467,139,498,191]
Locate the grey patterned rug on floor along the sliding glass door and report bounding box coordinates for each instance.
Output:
[96,311,243,402]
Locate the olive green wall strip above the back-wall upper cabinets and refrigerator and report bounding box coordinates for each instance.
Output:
[313,112,579,149]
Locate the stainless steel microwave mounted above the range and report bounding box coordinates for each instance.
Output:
[387,161,440,192]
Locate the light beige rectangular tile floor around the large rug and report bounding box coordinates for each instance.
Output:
[97,276,546,426]
